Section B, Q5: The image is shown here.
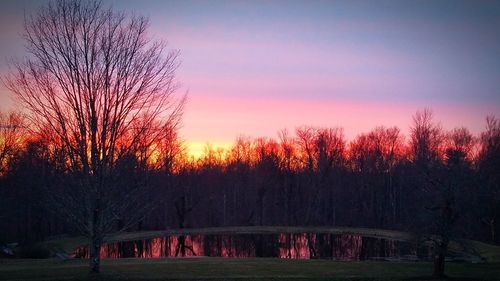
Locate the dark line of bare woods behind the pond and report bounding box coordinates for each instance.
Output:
[0,110,500,247]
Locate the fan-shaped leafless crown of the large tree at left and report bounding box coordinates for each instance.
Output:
[7,1,184,171]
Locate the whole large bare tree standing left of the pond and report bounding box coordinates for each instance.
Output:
[5,0,185,272]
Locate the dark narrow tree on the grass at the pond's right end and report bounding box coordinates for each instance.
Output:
[410,109,458,278]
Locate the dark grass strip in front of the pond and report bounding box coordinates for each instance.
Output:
[0,257,500,281]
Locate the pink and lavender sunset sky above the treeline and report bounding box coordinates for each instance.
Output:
[0,0,500,155]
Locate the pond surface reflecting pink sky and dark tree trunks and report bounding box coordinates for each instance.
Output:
[74,233,417,260]
